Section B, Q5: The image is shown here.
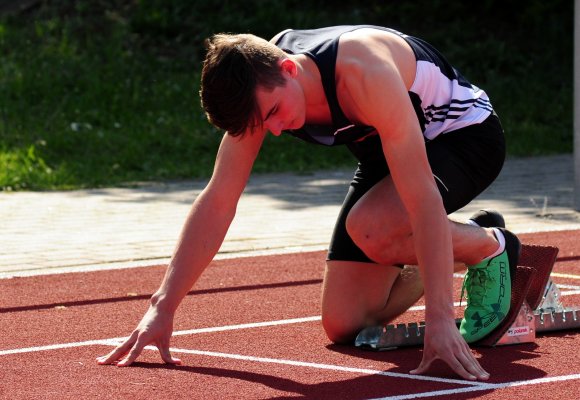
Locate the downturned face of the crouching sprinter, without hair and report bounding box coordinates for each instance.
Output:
[256,61,306,136]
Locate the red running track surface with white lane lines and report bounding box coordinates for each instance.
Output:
[0,231,580,400]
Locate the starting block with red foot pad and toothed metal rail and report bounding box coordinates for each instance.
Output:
[355,245,580,351]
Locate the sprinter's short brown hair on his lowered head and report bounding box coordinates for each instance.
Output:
[200,34,286,136]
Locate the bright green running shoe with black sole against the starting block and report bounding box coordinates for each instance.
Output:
[459,228,521,343]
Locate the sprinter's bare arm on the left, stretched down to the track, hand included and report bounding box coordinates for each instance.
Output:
[97,131,265,366]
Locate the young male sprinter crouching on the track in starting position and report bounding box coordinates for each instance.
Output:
[98,26,519,380]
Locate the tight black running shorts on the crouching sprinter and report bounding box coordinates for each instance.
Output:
[328,114,505,263]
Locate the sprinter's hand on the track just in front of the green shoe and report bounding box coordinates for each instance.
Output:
[411,321,489,381]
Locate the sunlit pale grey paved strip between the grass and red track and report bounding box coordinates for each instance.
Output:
[0,155,580,278]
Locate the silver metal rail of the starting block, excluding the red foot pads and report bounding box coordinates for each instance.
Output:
[355,246,580,351]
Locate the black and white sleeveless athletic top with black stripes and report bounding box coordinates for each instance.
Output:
[275,25,493,154]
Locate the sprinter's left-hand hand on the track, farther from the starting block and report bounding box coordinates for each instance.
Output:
[97,305,181,367]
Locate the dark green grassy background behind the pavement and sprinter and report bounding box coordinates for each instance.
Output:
[0,0,572,190]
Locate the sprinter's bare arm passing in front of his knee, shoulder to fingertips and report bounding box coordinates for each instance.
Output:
[341,48,488,379]
